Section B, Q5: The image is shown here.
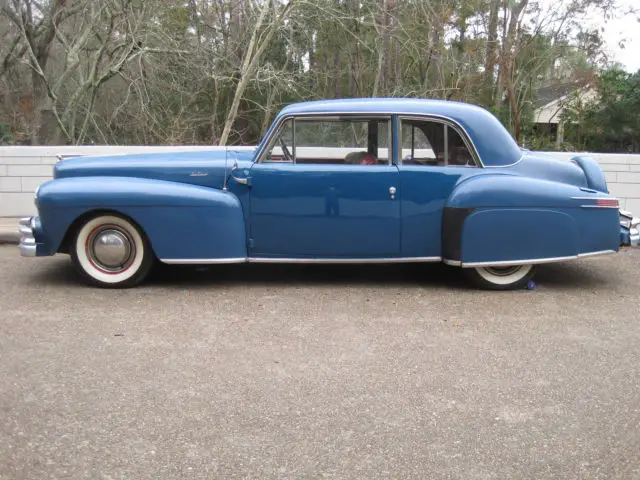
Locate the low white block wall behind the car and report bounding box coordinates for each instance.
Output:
[0,146,640,217]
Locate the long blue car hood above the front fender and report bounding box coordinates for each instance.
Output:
[53,147,256,188]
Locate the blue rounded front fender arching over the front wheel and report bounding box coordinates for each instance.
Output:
[36,177,247,261]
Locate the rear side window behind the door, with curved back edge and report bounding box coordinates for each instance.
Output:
[401,120,475,166]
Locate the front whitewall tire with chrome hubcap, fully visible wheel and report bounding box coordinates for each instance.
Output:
[71,214,154,288]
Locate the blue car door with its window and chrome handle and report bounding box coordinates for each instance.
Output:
[249,118,400,259]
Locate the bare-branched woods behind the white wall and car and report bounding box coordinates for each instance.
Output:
[0,0,632,148]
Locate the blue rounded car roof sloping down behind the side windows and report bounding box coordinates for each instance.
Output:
[274,98,522,166]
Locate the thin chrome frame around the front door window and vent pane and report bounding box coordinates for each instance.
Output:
[255,113,394,167]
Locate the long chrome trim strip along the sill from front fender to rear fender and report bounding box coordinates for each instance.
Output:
[160,257,442,265]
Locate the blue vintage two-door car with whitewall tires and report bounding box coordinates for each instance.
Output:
[20,99,640,289]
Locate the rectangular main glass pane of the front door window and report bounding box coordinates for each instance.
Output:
[294,117,391,165]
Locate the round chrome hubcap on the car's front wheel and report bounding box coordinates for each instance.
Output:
[87,226,133,272]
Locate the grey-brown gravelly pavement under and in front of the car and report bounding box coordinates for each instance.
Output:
[0,246,640,480]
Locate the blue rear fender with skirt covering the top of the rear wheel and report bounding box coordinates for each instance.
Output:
[443,174,619,266]
